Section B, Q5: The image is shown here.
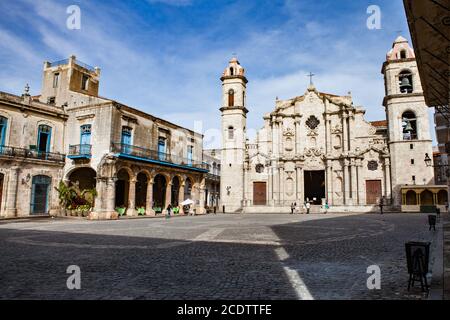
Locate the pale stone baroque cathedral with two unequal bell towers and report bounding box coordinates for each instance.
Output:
[220,37,447,213]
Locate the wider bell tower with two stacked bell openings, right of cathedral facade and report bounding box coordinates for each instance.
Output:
[382,36,434,206]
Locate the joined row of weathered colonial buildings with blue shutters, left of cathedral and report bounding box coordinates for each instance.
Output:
[0,56,209,218]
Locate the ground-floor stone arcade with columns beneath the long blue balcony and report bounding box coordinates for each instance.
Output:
[75,160,206,217]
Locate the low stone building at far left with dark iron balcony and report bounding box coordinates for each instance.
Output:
[0,88,67,217]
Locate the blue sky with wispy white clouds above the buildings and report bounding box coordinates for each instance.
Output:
[0,0,434,147]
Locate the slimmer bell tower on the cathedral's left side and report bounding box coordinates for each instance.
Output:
[220,58,248,213]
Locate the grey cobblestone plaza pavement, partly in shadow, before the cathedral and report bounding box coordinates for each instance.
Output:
[0,214,437,300]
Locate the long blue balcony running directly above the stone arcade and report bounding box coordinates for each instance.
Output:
[111,143,209,173]
